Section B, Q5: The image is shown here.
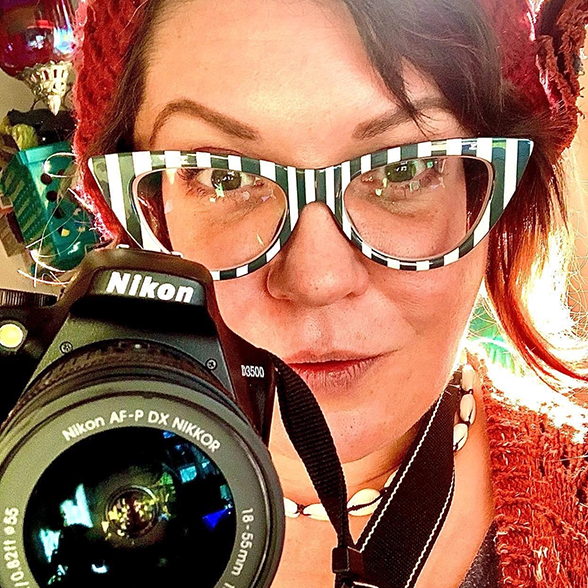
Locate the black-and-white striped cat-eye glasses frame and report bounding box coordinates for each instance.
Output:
[88,137,533,280]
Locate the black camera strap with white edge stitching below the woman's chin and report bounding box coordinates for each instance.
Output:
[274,358,459,588]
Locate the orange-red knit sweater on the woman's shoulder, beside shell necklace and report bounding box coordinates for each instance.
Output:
[479,364,588,588]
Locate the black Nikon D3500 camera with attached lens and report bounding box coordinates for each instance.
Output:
[0,249,284,588]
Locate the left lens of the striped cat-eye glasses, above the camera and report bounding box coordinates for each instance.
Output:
[134,168,287,271]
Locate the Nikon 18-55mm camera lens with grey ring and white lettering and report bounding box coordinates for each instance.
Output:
[0,341,284,588]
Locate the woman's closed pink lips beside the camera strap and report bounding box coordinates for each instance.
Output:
[288,355,384,393]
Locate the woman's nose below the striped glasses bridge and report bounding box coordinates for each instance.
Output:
[267,202,371,307]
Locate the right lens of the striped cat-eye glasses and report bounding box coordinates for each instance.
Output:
[344,156,493,260]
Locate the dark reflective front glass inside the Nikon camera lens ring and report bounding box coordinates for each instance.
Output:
[24,427,236,588]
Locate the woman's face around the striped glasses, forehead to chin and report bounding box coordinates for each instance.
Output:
[135,0,487,462]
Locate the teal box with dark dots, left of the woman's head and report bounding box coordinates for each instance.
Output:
[0,142,98,270]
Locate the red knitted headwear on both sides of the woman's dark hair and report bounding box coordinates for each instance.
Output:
[73,0,588,233]
